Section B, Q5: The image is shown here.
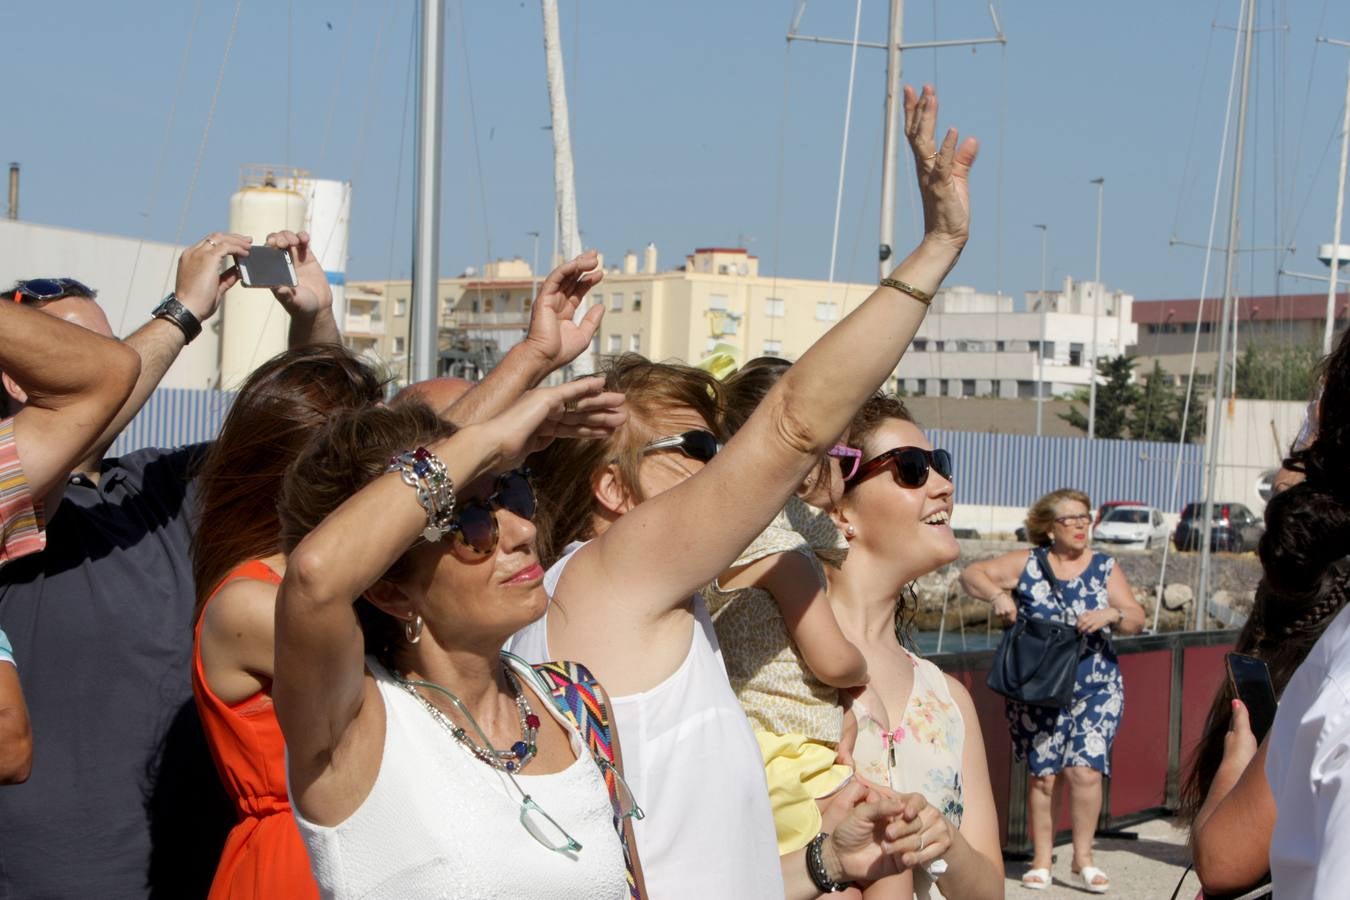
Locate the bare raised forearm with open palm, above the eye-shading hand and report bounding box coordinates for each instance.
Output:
[443,250,605,425]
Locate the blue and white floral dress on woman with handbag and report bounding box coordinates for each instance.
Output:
[1007,553,1125,776]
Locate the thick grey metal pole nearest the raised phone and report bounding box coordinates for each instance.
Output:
[409,0,444,382]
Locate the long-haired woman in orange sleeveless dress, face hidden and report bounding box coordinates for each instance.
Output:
[192,344,383,900]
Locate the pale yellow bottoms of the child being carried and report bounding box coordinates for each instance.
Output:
[755,731,853,855]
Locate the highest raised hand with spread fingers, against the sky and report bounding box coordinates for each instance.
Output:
[905,85,980,251]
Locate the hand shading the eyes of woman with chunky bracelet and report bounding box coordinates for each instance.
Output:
[482,375,628,470]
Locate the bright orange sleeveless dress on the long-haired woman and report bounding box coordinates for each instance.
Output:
[192,560,319,900]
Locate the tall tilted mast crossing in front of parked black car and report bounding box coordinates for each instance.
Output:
[1195,0,1257,631]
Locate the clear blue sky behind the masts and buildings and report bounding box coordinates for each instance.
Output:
[0,0,1350,298]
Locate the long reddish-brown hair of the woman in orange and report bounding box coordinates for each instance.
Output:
[192,344,385,621]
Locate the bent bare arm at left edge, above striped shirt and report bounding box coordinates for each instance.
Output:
[0,302,140,499]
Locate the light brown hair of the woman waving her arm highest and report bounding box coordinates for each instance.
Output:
[529,354,722,567]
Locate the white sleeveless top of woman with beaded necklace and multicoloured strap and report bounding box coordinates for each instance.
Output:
[288,657,628,900]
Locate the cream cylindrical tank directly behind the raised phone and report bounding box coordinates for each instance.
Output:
[220,166,305,390]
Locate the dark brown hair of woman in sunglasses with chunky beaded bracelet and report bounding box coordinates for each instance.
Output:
[278,398,456,668]
